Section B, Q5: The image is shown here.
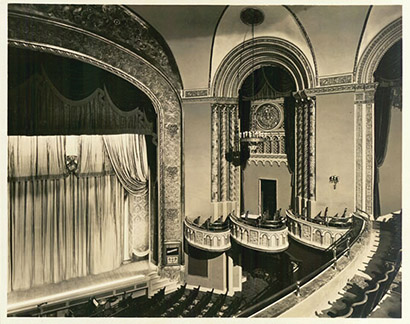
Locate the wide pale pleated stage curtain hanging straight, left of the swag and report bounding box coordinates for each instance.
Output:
[8,136,124,291]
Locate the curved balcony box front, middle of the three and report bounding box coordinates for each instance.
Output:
[230,215,289,253]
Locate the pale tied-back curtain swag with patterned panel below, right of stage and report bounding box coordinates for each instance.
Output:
[103,134,149,257]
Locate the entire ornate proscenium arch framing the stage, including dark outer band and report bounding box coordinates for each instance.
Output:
[8,5,184,278]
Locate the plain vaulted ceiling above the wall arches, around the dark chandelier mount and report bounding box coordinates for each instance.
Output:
[128,5,402,89]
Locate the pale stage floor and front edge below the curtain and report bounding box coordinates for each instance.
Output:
[7,261,163,316]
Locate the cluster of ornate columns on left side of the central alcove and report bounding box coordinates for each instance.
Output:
[211,103,240,202]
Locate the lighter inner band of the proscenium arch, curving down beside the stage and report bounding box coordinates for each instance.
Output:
[8,5,184,279]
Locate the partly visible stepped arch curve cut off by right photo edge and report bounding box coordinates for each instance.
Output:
[355,17,403,83]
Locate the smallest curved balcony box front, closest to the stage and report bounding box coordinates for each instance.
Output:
[184,218,231,252]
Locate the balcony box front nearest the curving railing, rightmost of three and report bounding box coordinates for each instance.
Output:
[286,210,351,250]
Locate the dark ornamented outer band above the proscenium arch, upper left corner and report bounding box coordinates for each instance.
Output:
[9,4,182,89]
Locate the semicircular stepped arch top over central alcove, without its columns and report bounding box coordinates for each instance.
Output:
[211,37,316,98]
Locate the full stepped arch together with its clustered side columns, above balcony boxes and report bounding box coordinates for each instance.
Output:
[211,36,316,218]
